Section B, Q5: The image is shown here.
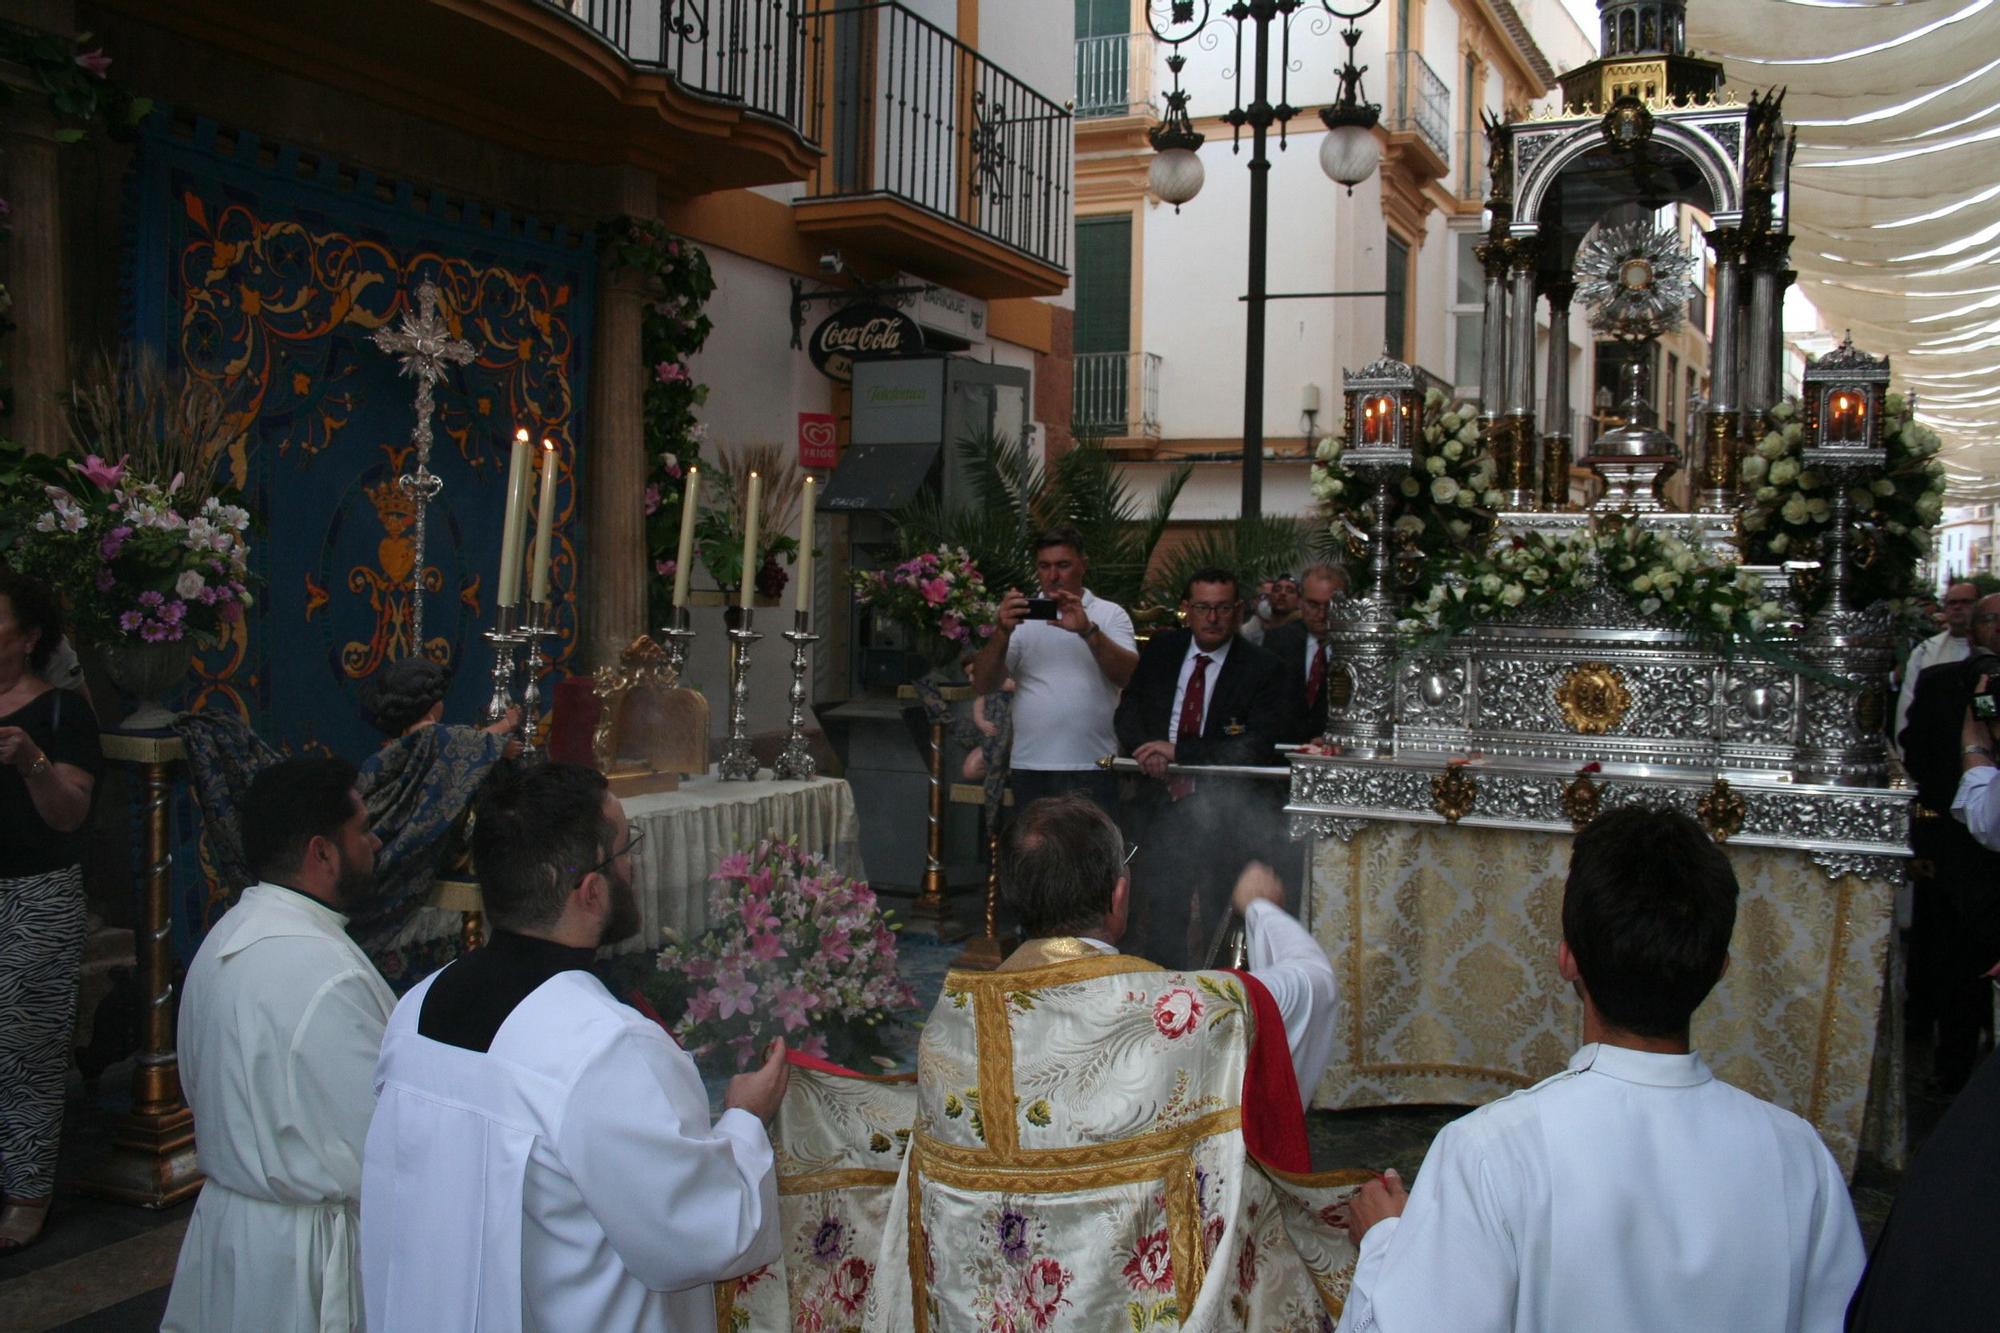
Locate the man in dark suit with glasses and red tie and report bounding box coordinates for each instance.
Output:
[1114,568,1300,967]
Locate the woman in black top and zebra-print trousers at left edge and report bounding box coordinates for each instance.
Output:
[0,568,104,1255]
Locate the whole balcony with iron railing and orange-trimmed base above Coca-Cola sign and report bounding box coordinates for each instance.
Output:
[792,0,1072,298]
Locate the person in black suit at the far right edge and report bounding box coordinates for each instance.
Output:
[1902,594,2000,1093]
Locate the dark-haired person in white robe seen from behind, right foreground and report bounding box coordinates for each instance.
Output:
[1340,807,1862,1333]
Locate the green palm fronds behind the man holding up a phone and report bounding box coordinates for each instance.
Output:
[900,434,1192,606]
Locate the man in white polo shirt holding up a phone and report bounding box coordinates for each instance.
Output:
[972,526,1138,819]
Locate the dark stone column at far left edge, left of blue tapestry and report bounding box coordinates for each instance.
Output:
[0,62,70,454]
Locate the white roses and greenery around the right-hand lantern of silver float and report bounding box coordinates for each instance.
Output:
[1742,394,1944,610]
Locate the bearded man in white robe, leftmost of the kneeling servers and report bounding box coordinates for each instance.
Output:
[164,759,396,1333]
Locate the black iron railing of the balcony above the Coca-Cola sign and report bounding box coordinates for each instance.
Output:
[806,2,1072,268]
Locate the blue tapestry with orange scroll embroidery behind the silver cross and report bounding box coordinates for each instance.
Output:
[126,114,596,949]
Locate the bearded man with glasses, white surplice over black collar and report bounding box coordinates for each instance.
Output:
[362,765,786,1333]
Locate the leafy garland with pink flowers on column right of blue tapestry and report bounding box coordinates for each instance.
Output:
[602,218,716,620]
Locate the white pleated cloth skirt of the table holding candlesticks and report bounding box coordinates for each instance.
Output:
[616,769,868,953]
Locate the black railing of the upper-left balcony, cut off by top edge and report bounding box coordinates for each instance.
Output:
[540,0,806,134]
